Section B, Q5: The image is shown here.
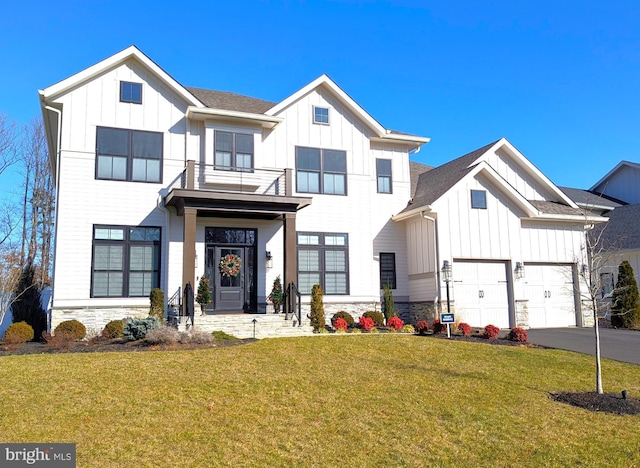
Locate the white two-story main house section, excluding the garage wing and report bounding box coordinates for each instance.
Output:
[40,46,429,329]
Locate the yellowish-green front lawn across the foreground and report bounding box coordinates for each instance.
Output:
[0,334,640,467]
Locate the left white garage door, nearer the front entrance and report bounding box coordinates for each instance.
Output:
[453,261,509,328]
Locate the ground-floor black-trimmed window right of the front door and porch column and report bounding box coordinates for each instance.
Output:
[297,232,349,295]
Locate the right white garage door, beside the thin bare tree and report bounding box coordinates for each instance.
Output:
[523,264,576,328]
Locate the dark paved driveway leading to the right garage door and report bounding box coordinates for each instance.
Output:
[527,328,640,365]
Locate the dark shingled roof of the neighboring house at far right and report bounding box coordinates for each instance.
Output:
[592,204,640,250]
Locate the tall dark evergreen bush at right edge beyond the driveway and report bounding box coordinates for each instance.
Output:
[611,260,640,328]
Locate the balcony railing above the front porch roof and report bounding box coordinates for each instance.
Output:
[169,161,293,196]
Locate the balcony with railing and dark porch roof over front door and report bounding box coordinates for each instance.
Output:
[164,161,311,219]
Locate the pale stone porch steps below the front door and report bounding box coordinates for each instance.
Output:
[179,313,313,339]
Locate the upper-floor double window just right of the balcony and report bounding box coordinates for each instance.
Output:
[296,146,347,195]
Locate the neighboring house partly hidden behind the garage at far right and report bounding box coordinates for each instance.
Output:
[563,161,640,306]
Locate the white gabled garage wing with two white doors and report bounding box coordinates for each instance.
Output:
[393,138,606,328]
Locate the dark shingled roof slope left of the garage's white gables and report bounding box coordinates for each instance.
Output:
[403,140,500,211]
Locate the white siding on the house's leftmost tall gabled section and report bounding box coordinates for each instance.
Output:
[54,60,192,309]
